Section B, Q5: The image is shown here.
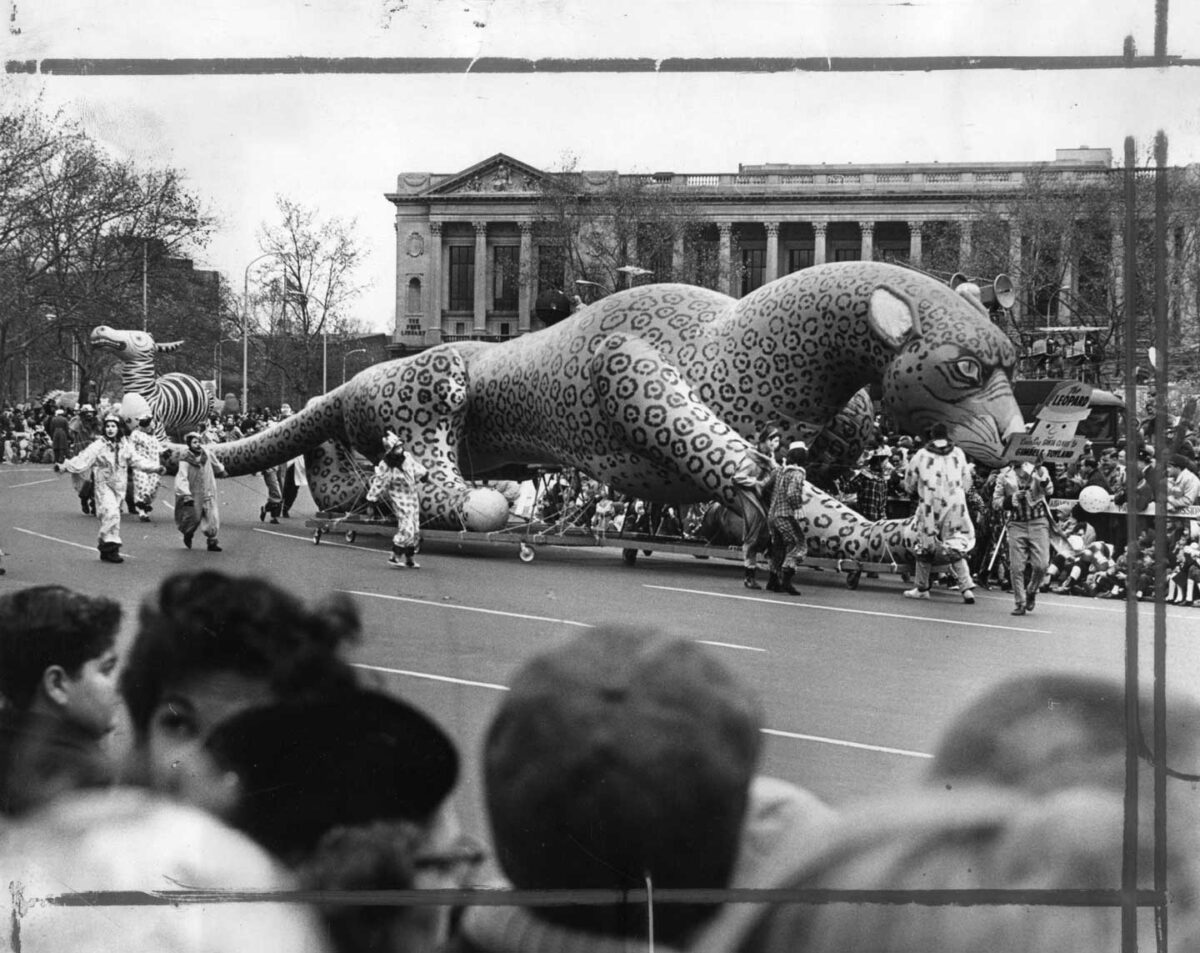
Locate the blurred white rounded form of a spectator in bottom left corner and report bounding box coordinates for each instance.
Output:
[0,789,329,953]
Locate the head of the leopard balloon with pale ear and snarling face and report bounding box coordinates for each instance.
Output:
[868,282,1024,467]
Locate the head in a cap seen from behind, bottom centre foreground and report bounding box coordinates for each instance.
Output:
[484,627,762,942]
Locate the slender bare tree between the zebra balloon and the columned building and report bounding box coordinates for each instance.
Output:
[248,196,367,406]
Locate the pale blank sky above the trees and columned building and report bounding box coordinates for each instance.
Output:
[7,0,1200,331]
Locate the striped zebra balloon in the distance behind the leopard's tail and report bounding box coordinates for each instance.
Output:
[90,325,217,440]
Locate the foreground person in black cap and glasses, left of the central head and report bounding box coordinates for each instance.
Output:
[206,690,470,953]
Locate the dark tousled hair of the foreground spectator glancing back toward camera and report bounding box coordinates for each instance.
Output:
[120,570,360,737]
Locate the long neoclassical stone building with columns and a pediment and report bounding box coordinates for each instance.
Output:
[386,146,1112,354]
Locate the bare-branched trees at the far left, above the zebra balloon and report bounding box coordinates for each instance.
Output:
[0,99,216,396]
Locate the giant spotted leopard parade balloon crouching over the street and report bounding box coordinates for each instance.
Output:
[204,262,1022,537]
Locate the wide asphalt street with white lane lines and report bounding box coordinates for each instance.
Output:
[0,464,1200,832]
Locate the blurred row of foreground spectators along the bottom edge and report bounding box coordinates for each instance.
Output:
[0,571,1200,953]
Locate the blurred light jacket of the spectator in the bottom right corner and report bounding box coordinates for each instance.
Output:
[691,787,1196,953]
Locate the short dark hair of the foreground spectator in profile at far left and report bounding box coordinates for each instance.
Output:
[0,586,121,711]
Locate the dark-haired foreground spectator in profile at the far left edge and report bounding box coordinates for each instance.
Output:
[0,586,121,815]
